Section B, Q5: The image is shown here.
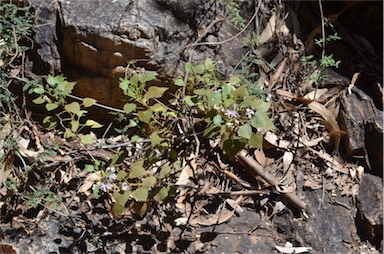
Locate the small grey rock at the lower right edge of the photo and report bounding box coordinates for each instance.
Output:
[356,174,383,249]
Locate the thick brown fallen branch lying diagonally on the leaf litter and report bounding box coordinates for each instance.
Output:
[236,150,306,209]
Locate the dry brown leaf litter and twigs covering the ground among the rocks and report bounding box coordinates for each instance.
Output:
[0,0,380,253]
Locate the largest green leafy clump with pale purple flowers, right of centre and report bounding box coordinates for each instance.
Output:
[175,58,274,155]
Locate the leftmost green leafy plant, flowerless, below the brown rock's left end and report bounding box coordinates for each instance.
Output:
[31,76,102,144]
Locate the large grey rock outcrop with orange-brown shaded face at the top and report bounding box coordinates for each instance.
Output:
[29,0,248,107]
